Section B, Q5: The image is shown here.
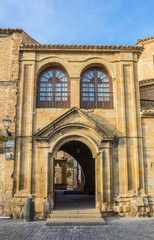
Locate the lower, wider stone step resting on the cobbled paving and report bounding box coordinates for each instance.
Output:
[46,218,106,226]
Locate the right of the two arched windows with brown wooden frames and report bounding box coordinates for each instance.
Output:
[80,68,113,109]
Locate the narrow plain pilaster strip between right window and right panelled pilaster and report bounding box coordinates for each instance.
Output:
[115,61,128,194]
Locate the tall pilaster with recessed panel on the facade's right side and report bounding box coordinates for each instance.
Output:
[123,63,139,190]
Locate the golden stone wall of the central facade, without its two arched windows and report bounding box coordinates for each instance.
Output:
[14,45,149,216]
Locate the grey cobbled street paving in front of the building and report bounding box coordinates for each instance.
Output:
[0,217,154,240]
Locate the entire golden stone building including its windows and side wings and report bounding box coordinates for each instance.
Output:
[0,29,154,217]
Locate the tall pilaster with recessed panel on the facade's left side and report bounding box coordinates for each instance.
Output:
[15,61,35,194]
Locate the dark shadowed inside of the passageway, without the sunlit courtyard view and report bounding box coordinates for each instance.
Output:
[55,141,95,210]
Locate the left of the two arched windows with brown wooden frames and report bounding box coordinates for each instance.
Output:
[37,67,70,108]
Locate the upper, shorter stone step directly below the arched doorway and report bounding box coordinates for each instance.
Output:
[49,213,102,219]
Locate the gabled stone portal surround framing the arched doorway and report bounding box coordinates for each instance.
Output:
[35,108,114,214]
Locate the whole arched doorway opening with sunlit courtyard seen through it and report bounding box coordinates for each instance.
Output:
[54,141,95,210]
